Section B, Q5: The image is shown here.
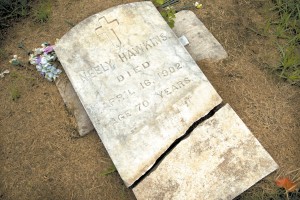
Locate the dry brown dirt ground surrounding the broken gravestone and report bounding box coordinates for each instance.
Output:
[0,0,300,200]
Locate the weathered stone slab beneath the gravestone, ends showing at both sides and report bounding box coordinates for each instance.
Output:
[57,10,227,136]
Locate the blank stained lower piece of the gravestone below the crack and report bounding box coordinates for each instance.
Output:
[133,104,278,200]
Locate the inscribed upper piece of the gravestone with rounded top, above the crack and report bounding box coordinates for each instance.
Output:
[55,1,222,186]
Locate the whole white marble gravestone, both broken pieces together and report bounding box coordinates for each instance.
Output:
[55,2,277,199]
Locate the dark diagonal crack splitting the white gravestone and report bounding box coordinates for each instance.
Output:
[129,102,225,189]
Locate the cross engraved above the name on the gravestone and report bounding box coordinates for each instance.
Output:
[95,16,121,47]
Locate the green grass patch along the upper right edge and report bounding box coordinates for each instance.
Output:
[266,0,300,85]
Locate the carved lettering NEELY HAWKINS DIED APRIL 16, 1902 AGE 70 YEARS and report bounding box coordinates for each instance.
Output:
[79,33,193,135]
